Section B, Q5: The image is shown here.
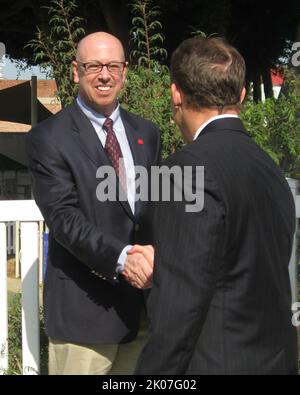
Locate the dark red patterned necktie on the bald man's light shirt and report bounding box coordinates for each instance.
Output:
[103,118,127,192]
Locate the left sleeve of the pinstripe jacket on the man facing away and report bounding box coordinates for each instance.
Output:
[136,154,225,375]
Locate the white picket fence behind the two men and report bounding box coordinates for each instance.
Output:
[0,179,300,375]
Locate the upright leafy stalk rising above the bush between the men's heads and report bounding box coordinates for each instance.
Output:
[130,0,167,69]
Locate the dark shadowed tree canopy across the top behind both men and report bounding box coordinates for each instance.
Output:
[0,0,300,89]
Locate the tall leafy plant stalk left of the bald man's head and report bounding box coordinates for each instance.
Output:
[27,0,85,107]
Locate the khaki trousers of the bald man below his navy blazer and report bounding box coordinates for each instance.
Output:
[49,337,146,375]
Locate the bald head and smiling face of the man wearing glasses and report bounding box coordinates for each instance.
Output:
[73,33,126,116]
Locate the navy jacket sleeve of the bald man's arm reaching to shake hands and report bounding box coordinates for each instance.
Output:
[26,129,125,282]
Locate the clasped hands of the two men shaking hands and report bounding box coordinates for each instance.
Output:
[122,245,154,289]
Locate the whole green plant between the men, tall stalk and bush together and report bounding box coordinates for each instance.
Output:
[121,0,182,157]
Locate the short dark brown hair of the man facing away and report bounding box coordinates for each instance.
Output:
[171,37,246,109]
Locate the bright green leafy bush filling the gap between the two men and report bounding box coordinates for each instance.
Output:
[120,66,183,157]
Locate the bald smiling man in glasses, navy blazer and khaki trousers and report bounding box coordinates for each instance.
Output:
[27,32,160,375]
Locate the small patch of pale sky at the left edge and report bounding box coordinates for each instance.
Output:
[0,57,49,80]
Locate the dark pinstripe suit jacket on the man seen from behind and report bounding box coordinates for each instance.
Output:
[136,118,297,374]
